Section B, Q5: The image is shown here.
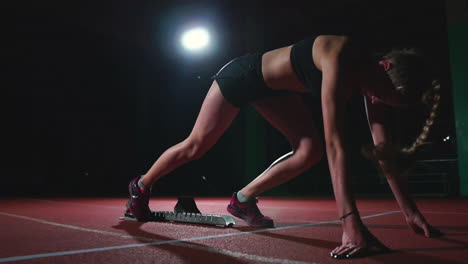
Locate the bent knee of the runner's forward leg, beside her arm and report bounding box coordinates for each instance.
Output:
[294,138,324,170]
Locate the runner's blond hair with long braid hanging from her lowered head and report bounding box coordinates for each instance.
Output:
[362,49,440,174]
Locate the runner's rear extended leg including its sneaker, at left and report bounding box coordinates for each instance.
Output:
[126,81,239,221]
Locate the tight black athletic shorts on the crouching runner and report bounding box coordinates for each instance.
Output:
[213,53,289,108]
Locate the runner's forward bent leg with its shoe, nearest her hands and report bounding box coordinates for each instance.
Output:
[227,93,323,227]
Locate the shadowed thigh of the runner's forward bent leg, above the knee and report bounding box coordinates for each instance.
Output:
[252,93,321,147]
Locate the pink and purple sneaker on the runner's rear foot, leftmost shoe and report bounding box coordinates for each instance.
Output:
[125,176,152,222]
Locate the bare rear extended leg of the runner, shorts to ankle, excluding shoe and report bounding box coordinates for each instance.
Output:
[141,81,239,186]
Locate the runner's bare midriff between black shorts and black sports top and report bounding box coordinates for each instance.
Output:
[262,45,312,93]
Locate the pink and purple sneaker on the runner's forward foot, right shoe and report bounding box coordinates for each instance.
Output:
[227,193,274,227]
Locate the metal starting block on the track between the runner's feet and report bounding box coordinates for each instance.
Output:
[120,196,236,227]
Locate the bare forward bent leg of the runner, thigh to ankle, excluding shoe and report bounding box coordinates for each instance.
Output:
[240,93,324,197]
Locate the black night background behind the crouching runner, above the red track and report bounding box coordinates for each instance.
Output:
[0,0,457,196]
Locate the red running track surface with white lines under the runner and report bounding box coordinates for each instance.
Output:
[0,197,468,264]
